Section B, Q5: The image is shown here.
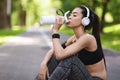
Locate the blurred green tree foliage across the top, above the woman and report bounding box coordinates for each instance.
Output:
[12,0,120,32]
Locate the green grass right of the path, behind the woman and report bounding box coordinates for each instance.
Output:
[61,24,120,52]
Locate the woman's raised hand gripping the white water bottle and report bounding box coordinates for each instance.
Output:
[52,16,65,33]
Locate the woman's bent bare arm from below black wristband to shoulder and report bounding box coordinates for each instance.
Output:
[53,36,91,60]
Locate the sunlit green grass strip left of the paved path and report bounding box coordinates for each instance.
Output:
[0,26,26,45]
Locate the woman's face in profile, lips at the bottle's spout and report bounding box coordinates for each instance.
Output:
[67,8,83,28]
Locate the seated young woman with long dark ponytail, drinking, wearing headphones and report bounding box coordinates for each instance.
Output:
[38,6,106,80]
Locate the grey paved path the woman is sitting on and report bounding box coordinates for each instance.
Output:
[0,27,120,80]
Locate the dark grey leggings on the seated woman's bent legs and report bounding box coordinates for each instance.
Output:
[36,56,103,80]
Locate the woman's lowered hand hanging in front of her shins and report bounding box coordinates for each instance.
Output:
[38,63,49,80]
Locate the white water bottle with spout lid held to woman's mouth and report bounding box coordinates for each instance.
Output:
[40,11,70,24]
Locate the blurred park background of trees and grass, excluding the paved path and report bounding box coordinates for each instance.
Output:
[0,0,120,52]
